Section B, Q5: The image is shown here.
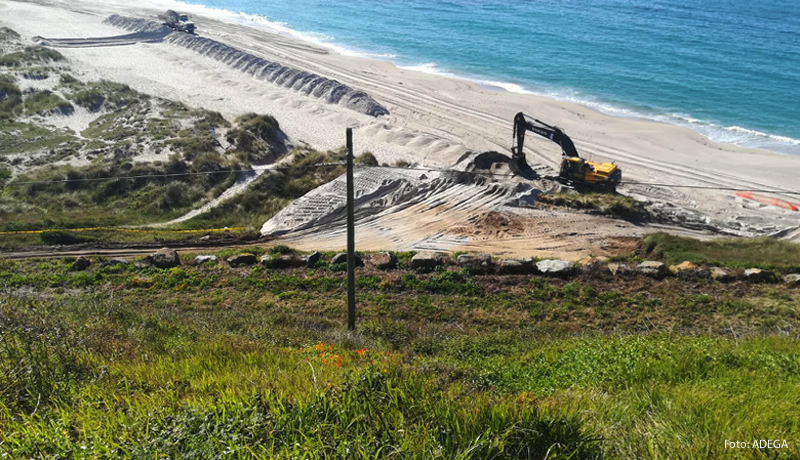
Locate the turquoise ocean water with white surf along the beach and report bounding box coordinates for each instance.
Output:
[164,0,800,154]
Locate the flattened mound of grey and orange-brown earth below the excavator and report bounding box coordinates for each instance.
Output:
[261,164,641,260]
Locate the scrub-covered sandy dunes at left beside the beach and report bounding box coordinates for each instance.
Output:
[0,28,322,243]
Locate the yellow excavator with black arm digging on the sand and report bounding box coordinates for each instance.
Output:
[511,112,622,191]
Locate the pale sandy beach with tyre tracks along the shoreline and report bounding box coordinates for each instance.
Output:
[0,0,800,248]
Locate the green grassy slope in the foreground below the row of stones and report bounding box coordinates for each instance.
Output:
[0,253,800,459]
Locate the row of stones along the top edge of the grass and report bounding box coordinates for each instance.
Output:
[73,249,800,286]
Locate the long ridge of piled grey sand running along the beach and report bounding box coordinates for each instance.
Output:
[104,15,389,117]
